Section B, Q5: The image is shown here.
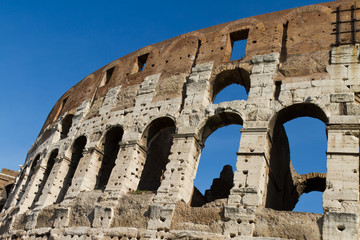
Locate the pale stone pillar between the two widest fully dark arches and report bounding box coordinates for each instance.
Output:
[105,141,147,199]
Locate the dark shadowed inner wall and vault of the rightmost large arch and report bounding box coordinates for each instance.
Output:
[265,103,328,210]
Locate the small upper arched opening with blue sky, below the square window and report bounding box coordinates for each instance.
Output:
[210,68,250,102]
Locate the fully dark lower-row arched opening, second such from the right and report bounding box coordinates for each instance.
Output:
[95,127,124,190]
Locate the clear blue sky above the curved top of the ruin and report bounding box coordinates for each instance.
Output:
[0,0,332,214]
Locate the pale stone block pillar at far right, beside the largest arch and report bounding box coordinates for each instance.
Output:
[323,125,359,240]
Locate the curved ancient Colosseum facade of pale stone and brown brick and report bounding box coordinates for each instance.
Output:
[0,0,360,240]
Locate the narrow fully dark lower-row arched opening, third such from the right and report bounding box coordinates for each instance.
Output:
[56,136,87,203]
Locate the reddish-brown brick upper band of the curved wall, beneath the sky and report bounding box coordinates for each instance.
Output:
[40,0,340,135]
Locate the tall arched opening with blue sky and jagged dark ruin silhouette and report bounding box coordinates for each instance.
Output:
[191,113,243,207]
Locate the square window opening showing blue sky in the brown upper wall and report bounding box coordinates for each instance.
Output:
[230,29,249,61]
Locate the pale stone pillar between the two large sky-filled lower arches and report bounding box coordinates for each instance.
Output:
[224,128,269,236]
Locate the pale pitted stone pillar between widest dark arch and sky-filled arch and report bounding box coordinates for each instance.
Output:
[148,133,203,229]
